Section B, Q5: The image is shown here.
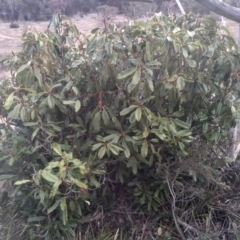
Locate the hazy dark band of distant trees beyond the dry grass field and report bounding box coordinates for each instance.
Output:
[0,0,237,21]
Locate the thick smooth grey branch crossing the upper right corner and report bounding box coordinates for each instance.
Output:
[195,0,240,23]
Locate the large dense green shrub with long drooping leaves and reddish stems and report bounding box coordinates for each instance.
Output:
[0,14,240,239]
